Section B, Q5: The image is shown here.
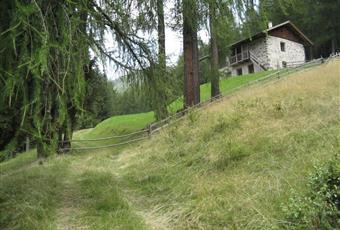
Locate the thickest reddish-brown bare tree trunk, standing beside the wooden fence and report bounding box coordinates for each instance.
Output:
[182,0,200,107]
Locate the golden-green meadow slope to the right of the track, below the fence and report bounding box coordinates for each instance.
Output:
[117,61,340,229]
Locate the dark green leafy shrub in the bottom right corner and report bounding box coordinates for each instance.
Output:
[283,156,340,229]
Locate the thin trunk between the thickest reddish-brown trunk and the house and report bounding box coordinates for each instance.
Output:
[209,3,220,97]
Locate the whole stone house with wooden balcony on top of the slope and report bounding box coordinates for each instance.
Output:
[227,21,313,76]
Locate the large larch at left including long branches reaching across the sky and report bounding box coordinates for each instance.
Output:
[0,0,155,158]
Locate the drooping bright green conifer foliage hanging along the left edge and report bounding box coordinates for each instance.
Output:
[0,1,88,157]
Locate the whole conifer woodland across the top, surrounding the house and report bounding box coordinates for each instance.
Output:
[0,0,340,160]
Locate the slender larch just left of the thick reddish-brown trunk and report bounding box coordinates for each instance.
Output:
[130,0,170,120]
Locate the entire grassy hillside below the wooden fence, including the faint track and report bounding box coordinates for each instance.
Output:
[0,61,340,229]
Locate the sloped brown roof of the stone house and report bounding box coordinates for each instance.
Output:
[229,21,313,47]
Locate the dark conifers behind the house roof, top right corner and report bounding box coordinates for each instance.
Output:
[259,0,340,58]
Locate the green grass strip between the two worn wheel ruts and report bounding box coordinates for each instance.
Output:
[79,171,144,229]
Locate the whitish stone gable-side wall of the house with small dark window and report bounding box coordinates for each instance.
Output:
[266,36,306,69]
